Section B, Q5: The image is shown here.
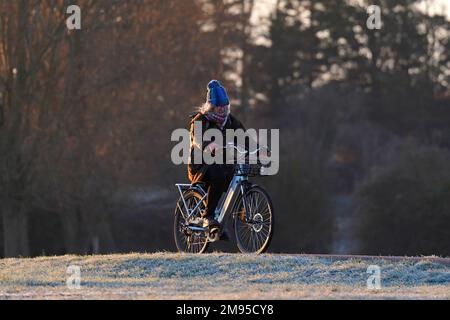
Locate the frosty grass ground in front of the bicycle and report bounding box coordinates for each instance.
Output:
[0,253,450,299]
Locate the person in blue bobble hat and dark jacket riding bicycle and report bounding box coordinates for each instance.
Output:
[188,80,245,228]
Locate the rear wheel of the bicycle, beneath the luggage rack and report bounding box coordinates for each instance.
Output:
[173,190,209,254]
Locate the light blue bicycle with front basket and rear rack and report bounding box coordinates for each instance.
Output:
[174,145,274,254]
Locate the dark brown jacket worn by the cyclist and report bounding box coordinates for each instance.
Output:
[188,113,245,183]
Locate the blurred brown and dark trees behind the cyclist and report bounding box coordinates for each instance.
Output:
[0,0,450,257]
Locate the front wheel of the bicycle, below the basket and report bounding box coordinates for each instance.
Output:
[234,186,274,254]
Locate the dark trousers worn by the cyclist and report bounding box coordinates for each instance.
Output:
[202,164,233,217]
